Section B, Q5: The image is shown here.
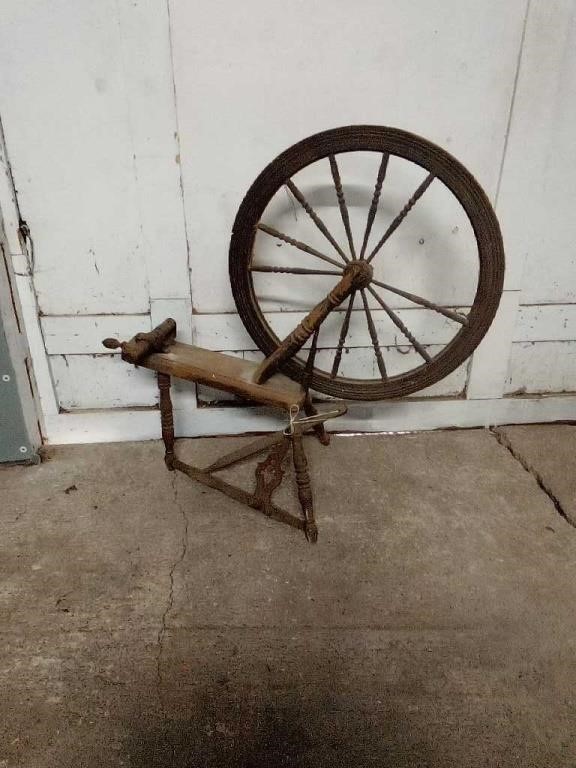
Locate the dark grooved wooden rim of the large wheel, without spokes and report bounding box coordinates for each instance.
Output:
[229,126,504,400]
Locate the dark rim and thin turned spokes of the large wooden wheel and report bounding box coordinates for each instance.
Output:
[229,126,504,400]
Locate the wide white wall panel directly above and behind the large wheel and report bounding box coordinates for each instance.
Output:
[170,0,526,312]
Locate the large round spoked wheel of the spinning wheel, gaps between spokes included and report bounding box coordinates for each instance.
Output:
[229,126,504,400]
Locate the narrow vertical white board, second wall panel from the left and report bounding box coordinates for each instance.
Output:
[115,0,190,302]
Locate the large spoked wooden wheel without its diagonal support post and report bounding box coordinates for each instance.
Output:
[229,126,504,400]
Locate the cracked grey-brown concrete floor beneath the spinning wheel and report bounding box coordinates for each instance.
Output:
[0,426,576,768]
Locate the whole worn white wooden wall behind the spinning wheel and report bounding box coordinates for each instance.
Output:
[0,0,576,442]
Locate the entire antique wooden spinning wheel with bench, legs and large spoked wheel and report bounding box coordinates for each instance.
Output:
[103,126,504,541]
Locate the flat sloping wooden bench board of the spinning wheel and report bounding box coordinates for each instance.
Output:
[139,341,306,411]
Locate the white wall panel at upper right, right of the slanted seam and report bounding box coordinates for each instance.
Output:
[497,0,576,300]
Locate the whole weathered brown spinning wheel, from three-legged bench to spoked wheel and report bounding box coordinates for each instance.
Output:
[103,126,504,542]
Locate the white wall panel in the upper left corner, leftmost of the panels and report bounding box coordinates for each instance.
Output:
[0,0,148,314]
